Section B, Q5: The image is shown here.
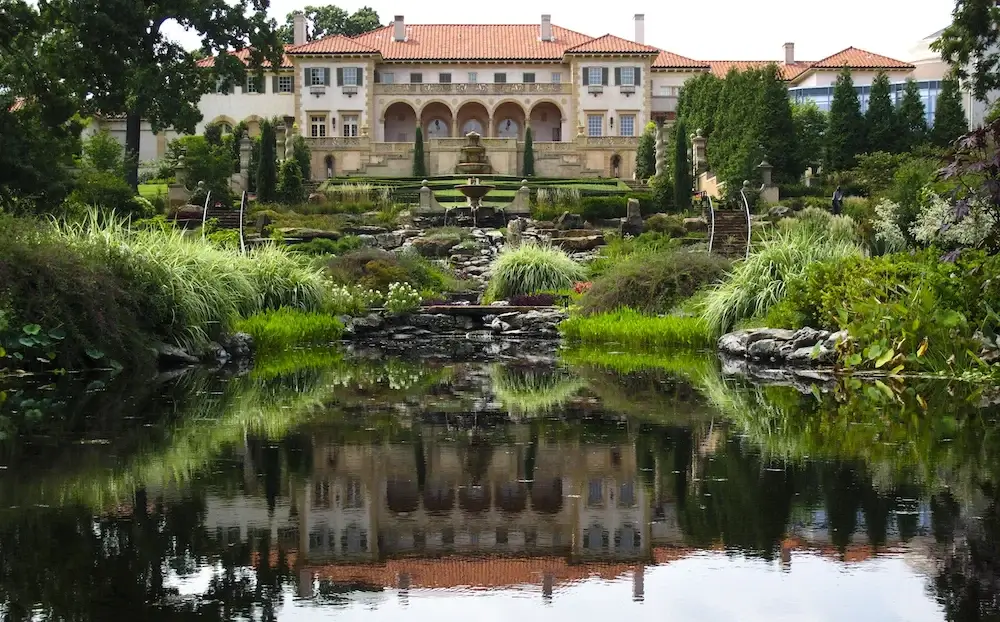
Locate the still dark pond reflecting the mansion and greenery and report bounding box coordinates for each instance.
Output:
[0,350,1000,622]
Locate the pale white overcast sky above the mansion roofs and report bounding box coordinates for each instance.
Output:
[173,0,954,60]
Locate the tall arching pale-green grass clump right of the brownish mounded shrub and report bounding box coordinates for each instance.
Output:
[701,230,862,332]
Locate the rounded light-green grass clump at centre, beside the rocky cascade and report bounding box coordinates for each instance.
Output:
[485,243,586,300]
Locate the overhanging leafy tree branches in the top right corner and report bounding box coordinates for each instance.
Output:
[931,0,1000,101]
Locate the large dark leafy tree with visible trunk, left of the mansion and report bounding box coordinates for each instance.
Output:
[39,0,282,187]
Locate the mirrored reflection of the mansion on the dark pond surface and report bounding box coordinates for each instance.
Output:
[206,426,929,597]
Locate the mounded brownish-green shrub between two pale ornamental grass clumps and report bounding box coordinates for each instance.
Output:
[580,251,729,315]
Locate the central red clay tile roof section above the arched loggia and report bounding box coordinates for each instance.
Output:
[354,24,592,61]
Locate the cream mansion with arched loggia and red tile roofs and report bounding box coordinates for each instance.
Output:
[91,14,936,179]
